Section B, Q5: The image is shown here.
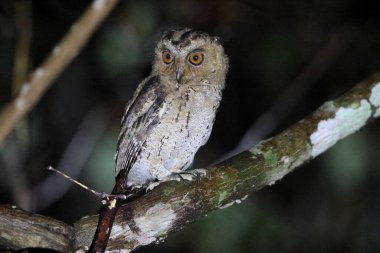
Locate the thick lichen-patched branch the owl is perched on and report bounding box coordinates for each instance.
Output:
[0,72,380,252]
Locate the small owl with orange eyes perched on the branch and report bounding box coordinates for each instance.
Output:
[115,29,228,187]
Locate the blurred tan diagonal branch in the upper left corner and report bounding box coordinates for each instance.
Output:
[0,0,118,143]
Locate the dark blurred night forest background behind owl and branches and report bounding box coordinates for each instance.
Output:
[0,0,380,253]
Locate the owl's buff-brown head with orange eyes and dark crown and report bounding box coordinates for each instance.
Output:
[153,28,228,87]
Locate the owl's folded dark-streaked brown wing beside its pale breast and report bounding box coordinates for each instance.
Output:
[115,76,164,176]
